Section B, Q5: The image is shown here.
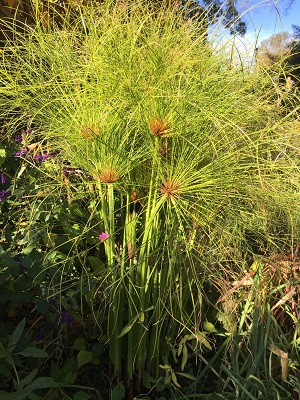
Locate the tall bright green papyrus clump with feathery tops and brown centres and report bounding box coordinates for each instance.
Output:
[0,0,300,394]
